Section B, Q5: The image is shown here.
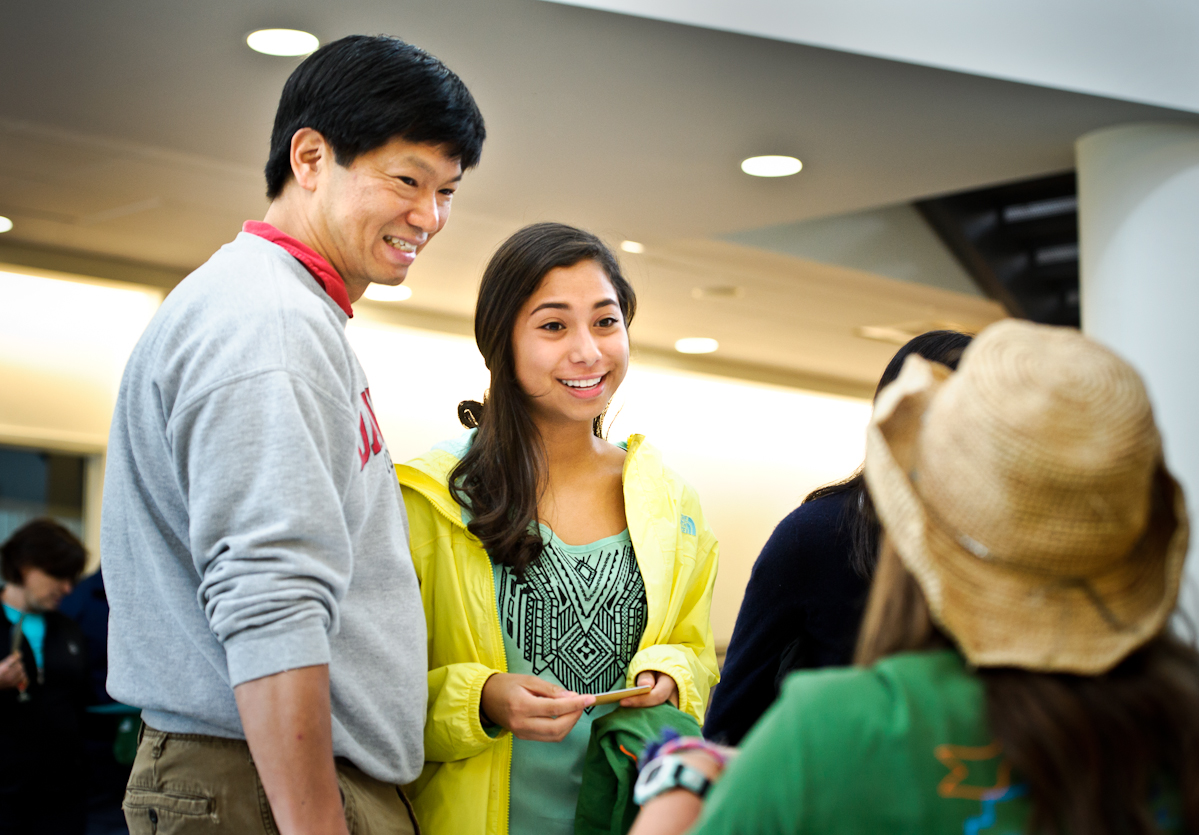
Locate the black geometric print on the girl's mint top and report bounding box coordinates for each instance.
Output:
[496,535,647,713]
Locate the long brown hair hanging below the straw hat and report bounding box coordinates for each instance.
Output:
[854,536,1199,835]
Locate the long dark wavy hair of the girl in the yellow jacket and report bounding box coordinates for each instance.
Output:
[450,223,637,575]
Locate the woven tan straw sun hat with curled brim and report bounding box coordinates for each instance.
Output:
[866,320,1187,674]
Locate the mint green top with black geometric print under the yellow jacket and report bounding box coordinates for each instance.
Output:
[494,525,649,835]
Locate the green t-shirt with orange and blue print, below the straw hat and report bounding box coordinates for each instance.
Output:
[693,650,1181,835]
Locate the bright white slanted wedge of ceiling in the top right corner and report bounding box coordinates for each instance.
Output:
[549,0,1199,110]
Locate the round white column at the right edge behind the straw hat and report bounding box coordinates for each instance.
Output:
[1077,124,1199,627]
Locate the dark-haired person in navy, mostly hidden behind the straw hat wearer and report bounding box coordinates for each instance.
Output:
[704,330,971,745]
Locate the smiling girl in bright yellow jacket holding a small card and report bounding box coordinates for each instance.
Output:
[397,223,717,835]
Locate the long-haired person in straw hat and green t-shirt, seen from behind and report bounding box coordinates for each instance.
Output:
[632,320,1199,835]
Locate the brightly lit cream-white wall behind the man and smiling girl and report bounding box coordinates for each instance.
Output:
[0,269,869,644]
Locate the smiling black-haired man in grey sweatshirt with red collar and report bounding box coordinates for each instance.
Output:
[102,36,484,835]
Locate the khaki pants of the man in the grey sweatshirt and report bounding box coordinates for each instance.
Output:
[125,726,420,835]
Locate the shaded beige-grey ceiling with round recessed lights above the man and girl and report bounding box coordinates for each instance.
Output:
[0,0,1193,394]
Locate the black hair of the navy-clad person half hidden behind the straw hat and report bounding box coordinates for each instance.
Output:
[803,330,971,579]
